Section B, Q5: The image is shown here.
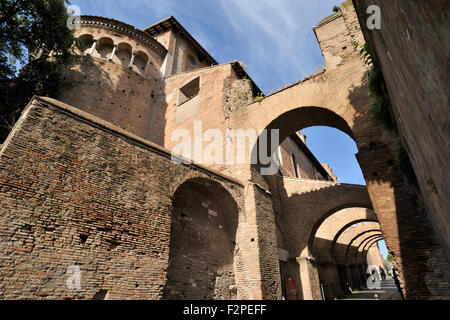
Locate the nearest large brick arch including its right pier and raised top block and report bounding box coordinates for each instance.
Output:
[223,1,445,297]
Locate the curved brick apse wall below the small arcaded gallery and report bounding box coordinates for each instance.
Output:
[58,56,165,143]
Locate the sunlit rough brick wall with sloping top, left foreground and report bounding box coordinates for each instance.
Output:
[0,99,250,299]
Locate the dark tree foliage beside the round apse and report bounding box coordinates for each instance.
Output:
[0,0,75,142]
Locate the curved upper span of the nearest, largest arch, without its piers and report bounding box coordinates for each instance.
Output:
[230,70,369,147]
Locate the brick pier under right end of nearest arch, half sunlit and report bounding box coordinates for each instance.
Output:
[357,145,450,299]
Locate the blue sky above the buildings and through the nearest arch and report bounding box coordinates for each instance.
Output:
[71,0,365,184]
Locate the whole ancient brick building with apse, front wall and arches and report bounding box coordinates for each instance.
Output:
[0,1,450,299]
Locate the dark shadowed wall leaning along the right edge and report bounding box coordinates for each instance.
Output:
[353,0,450,259]
